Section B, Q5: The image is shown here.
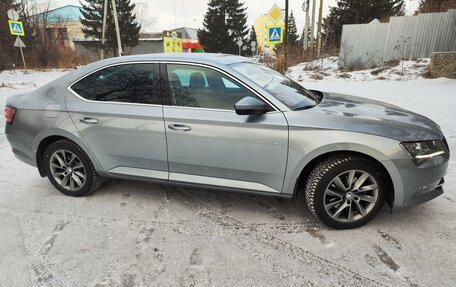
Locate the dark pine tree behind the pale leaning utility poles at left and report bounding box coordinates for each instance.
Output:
[80,0,141,55]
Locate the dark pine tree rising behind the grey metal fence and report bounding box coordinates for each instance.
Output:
[324,0,405,45]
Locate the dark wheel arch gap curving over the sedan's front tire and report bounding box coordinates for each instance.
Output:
[293,150,395,208]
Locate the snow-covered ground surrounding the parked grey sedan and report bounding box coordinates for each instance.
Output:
[0,63,456,286]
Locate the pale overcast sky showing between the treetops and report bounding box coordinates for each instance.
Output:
[50,0,419,32]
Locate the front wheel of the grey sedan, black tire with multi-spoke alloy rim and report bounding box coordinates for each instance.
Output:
[305,153,387,229]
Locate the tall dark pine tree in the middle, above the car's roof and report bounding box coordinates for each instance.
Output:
[198,0,250,54]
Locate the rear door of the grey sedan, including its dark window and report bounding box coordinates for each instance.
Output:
[66,63,168,180]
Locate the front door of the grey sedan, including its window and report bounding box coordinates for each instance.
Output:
[162,63,288,193]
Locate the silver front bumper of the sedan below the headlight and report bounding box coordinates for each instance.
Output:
[384,159,448,208]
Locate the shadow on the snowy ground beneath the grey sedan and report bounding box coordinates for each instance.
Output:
[90,180,442,233]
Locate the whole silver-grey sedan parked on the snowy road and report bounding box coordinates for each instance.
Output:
[5,54,449,229]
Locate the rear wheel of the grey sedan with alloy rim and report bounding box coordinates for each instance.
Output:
[43,140,100,196]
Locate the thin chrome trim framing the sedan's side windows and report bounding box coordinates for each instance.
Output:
[66,60,280,112]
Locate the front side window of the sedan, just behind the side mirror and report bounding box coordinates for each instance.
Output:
[167,64,256,110]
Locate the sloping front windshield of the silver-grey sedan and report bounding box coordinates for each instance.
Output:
[230,62,319,110]
